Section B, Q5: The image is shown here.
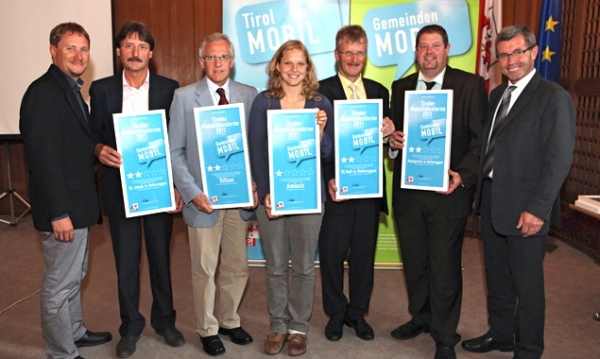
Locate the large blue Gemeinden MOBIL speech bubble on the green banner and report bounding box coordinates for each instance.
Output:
[363,0,473,80]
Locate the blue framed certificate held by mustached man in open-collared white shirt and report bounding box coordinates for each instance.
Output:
[113,110,175,218]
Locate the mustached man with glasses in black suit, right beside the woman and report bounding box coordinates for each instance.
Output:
[319,25,394,341]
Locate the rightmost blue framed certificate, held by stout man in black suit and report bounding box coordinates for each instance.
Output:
[400,90,453,191]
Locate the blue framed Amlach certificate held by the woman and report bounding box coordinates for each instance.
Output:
[267,108,321,215]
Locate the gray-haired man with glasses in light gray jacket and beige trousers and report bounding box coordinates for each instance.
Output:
[169,33,258,355]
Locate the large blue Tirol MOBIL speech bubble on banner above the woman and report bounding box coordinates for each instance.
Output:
[235,0,342,64]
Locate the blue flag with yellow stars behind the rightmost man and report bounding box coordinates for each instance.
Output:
[535,0,562,82]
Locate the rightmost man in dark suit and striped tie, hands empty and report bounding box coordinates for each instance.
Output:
[462,25,575,359]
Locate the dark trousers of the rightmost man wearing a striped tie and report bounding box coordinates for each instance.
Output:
[481,180,546,359]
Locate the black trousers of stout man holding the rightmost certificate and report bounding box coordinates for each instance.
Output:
[394,192,467,344]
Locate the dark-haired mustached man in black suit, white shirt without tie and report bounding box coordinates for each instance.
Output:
[90,22,185,358]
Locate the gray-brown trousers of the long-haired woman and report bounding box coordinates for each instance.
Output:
[256,205,323,334]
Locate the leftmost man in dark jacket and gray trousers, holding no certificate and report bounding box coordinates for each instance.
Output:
[19,23,112,358]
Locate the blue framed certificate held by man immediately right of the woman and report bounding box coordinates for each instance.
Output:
[333,99,383,199]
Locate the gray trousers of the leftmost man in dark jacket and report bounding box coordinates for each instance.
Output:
[41,228,89,359]
